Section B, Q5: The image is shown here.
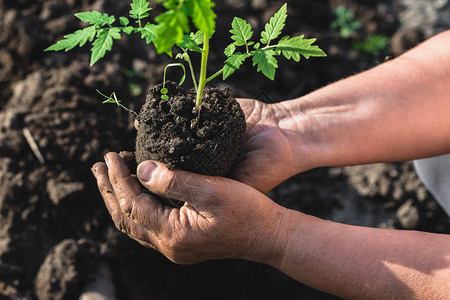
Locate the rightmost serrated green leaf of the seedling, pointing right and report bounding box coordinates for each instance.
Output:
[276,35,327,61]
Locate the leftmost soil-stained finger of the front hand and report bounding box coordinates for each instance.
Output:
[92,163,157,250]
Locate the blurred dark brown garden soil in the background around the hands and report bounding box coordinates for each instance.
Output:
[0,0,450,299]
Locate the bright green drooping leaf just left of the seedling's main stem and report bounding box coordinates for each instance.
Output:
[154,10,189,53]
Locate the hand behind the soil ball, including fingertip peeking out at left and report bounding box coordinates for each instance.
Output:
[134,99,315,193]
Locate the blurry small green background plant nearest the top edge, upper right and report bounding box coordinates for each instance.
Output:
[330,5,362,39]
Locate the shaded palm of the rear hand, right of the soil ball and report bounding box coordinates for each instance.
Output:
[230,99,297,193]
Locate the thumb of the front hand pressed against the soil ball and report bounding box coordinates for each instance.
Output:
[137,160,214,204]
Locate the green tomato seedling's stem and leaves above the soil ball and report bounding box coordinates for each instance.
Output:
[45,0,326,108]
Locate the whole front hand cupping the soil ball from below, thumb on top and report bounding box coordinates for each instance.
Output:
[93,153,286,264]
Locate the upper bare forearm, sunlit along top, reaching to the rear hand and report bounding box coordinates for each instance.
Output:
[277,31,450,170]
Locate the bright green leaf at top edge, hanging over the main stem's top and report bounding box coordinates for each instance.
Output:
[186,0,217,37]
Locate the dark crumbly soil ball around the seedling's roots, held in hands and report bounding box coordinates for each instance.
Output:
[136,82,246,176]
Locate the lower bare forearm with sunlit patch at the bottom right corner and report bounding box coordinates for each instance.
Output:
[271,211,450,299]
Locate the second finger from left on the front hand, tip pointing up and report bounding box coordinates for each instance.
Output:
[105,152,169,233]
